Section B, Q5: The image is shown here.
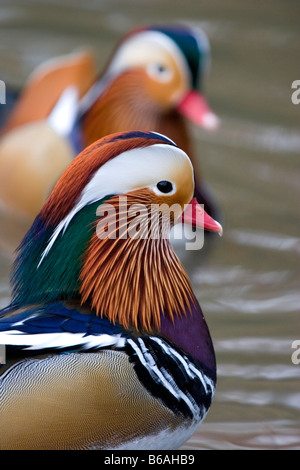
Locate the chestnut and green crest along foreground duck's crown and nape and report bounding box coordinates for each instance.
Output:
[12,132,186,305]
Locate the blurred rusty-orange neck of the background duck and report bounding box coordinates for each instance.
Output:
[82,70,190,152]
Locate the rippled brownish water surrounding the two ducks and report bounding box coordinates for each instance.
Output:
[0,0,300,449]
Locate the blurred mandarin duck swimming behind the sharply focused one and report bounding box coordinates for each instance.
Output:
[0,25,218,224]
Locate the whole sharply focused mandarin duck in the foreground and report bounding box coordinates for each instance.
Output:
[0,131,221,450]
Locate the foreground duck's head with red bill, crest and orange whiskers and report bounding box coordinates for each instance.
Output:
[13,132,221,331]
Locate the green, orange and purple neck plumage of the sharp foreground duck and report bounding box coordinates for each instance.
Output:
[13,195,215,375]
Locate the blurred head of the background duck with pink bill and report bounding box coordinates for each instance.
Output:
[81,25,218,143]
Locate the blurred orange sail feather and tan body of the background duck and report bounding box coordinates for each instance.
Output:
[0,51,96,222]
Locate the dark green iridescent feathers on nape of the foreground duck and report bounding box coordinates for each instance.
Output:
[12,198,106,305]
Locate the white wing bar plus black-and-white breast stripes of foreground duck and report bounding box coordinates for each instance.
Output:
[0,322,215,422]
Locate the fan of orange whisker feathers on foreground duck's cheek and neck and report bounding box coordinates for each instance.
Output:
[79,190,195,332]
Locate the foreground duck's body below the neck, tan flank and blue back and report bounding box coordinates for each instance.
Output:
[0,302,215,450]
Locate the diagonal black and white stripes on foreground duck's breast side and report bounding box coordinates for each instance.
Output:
[125,336,215,421]
